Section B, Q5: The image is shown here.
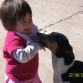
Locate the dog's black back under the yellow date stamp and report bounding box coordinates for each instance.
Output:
[62,60,83,83]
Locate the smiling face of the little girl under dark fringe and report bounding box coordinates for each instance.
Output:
[15,14,33,34]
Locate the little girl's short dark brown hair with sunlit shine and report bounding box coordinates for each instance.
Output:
[0,0,32,30]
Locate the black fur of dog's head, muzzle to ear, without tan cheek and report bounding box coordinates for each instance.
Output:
[37,32,75,65]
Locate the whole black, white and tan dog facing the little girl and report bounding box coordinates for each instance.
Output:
[37,32,83,83]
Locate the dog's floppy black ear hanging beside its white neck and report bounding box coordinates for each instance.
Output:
[64,45,75,65]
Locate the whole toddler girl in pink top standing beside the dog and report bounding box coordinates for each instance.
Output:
[0,0,41,83]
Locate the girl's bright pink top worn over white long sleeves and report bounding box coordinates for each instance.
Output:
[3,24,39,81]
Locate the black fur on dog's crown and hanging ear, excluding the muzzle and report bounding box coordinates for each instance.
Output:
[51,32,75,65]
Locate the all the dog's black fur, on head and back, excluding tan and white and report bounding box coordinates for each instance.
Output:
[37,32,83,83]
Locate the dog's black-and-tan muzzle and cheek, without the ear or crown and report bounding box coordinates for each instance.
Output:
[37,32,58,53]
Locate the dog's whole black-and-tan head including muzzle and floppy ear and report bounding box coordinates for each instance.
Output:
[37,32,75,65]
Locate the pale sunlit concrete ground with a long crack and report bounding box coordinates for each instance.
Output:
[0,0,83,83]
